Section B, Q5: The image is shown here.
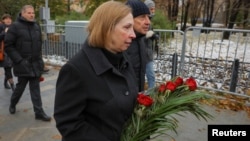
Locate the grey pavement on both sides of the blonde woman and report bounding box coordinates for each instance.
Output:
[0,67,250,141]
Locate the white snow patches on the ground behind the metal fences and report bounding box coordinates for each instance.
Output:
[43,28,250,69]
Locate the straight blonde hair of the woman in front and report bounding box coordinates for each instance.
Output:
[87,1,132,48]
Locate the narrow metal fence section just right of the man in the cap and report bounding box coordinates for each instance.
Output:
[151,29,184,82]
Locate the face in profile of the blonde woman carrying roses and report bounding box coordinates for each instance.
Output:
[106,13,136,53]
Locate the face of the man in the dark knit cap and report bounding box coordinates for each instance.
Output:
[134,14,150,35]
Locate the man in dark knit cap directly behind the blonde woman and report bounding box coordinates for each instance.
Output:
[125,0,150,91]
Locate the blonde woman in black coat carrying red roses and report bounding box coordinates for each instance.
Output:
[54,1,138,141]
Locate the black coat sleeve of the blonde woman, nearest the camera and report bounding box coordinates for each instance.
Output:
[54,64,109,141]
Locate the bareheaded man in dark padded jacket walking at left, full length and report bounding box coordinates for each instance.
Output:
[4,5,51,121]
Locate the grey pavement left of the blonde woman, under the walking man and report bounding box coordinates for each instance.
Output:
[0,67,61,141]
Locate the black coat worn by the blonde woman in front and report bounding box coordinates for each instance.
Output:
[54,43,138,141]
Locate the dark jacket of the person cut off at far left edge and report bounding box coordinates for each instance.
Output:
[0,24,12,67]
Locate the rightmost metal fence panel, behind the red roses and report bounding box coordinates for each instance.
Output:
[179,27,250,97]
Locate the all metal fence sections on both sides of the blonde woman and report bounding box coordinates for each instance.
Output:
[42,25,250,97]
